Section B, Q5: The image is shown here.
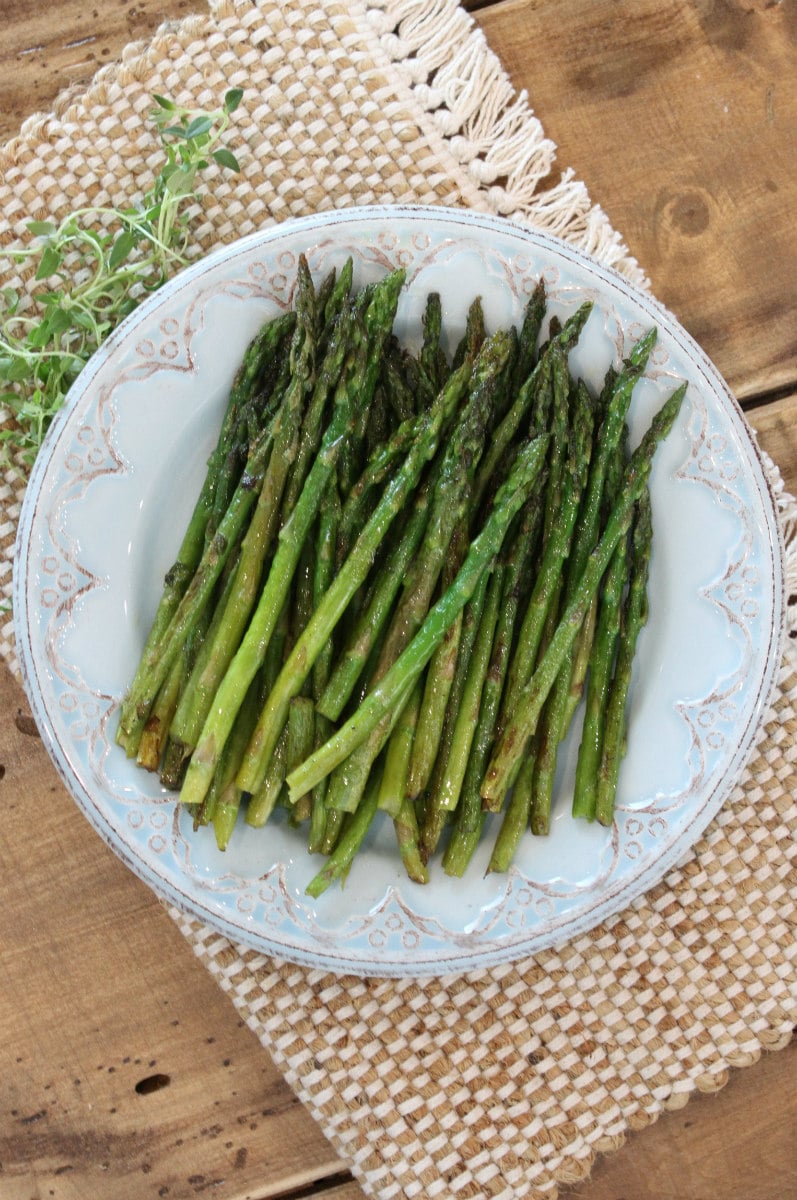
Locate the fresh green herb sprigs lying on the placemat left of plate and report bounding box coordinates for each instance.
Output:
[0,88,242,466]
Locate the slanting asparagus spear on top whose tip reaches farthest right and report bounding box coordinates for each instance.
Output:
[481,384,687,808]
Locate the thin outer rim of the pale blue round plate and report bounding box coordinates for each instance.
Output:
[12,203,786,978]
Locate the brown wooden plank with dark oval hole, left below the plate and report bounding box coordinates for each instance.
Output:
[0,667,346,1200]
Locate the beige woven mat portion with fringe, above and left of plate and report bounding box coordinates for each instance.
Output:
[0,0,643,667]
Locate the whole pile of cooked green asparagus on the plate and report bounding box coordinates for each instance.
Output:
[116,258,685,895]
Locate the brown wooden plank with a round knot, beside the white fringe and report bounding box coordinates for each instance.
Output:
[475,0,797,397]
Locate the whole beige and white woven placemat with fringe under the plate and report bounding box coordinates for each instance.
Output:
[0,0,797,1200]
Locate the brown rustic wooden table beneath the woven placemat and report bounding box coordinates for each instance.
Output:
[0,0,797,1200]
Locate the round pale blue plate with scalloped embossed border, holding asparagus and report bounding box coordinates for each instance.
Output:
[14,206,784,976]
